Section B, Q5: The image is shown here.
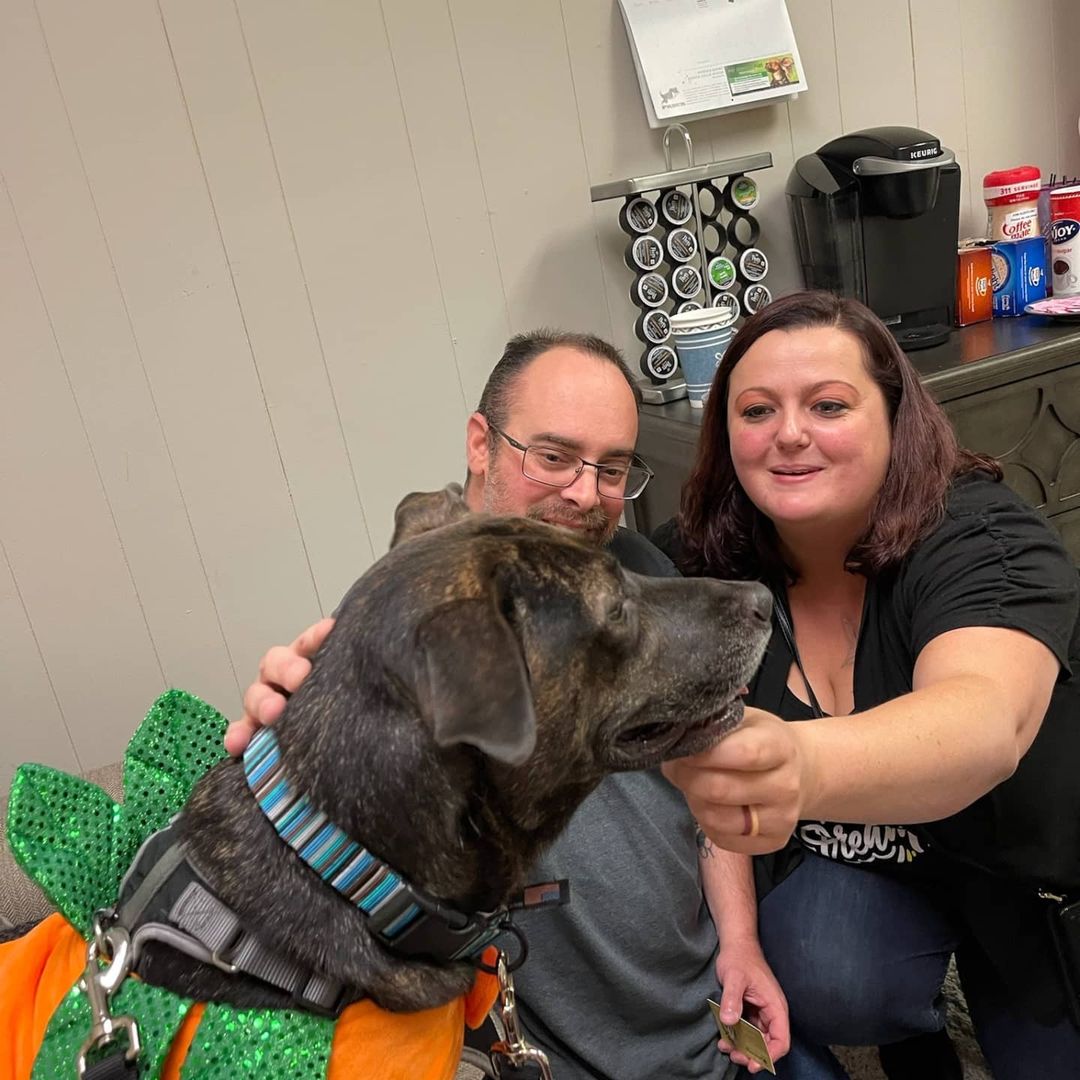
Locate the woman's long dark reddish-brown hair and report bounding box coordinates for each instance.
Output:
[676,293,1001,582]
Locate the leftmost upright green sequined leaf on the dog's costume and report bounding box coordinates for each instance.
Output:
[8,765,120,936]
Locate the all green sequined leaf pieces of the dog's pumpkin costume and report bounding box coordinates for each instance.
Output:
[21,690,334,1080]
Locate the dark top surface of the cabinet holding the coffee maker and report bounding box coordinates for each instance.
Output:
[639,315,1080,429]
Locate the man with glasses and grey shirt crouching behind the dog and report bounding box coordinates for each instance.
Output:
[227,330,787,1080]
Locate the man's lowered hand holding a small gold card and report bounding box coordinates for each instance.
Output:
[716,937,792,1072]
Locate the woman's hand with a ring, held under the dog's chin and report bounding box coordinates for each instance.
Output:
[663,706,818,855]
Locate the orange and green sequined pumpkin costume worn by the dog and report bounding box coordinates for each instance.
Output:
[0,690,497,1080]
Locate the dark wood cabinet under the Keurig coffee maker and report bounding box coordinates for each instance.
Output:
[627,316,1080,564]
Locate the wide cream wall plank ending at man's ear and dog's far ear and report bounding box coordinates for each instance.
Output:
[239,0,465,552]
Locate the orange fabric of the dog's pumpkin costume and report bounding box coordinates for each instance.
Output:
[0,915,498,1080]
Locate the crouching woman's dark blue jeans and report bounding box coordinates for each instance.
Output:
[758,853,1080,1080]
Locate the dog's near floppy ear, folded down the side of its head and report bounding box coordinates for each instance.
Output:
[417,597,537,765]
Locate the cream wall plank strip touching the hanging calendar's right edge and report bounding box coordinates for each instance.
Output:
[787,0,851,158]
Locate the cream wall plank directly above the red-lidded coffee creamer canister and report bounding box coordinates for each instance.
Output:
[961,0,1059,198]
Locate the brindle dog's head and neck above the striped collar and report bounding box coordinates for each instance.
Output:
[279,492,770,899]
